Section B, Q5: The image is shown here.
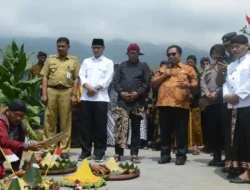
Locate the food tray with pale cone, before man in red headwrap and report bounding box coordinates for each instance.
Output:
[91,157,140,180]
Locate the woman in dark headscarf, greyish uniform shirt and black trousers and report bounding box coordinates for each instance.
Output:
[200,44,226,167]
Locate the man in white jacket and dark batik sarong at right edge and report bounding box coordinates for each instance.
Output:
[223,35,250,183]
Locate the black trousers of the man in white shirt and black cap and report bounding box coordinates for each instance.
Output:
[80,101,108,156]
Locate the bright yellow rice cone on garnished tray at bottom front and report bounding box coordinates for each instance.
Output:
[61,159,106,189]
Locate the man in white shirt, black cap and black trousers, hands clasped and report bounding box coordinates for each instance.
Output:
[78,39,114,162]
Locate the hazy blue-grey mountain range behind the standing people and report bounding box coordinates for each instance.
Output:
[0,37,208,68]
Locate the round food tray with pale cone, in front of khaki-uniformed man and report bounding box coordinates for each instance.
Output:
[22,153,77,175]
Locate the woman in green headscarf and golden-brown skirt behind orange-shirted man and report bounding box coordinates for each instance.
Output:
[186,55,203,155]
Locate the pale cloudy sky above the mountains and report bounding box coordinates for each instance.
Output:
[0,0,250,50]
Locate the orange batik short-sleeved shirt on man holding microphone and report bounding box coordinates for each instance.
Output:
[155,63,197,109]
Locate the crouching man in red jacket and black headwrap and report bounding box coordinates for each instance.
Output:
[0,100,43,178]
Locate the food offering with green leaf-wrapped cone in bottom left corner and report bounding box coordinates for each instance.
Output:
[0,154,60,190]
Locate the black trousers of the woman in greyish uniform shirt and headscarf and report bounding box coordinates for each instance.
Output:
[204,104,224,161]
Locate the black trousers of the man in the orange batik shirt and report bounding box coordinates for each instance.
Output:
[159,106,189,159]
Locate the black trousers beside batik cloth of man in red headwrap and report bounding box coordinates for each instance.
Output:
[115,114,142,156]
